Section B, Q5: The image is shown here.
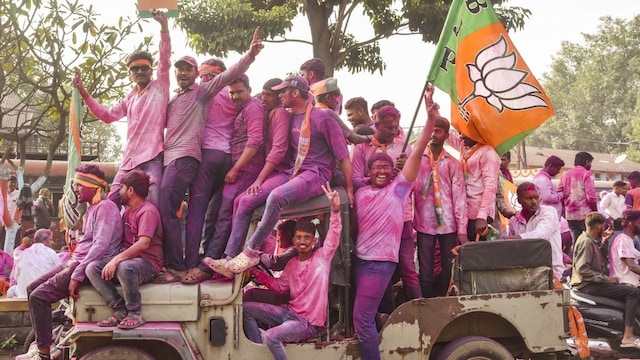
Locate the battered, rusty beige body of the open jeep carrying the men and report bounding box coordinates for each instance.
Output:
[59,188,569,360]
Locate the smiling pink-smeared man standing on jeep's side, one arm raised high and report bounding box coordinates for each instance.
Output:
[353,103,437,360]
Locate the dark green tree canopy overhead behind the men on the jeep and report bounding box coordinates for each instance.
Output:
[178,0,530,76]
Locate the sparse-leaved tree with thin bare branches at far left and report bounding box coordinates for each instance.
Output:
[0,0,150,175]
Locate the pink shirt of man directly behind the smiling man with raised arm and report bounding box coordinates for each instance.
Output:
[351,137,413,221]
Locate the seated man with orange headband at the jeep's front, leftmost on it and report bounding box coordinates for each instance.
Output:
[16,165,123,359]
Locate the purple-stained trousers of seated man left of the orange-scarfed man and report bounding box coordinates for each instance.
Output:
[224,173,289,257]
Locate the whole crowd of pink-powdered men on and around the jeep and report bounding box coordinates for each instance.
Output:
[0,12,640,359]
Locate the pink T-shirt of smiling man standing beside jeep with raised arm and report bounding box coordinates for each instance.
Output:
[354,173,413,263]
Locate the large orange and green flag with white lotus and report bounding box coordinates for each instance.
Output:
[429,0,554,155]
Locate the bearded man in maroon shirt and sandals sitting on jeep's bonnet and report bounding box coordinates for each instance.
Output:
[86,170,162,329]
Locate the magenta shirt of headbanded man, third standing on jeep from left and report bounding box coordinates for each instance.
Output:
[202,87,238,154]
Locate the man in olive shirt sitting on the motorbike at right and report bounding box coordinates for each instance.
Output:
[571,212,640,348]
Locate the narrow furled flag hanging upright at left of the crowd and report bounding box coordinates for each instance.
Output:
[62,87,82,229]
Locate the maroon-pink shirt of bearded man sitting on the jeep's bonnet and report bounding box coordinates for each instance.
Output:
[120,201,163,273]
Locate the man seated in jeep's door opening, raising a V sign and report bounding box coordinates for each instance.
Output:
[242,182,342,359]
